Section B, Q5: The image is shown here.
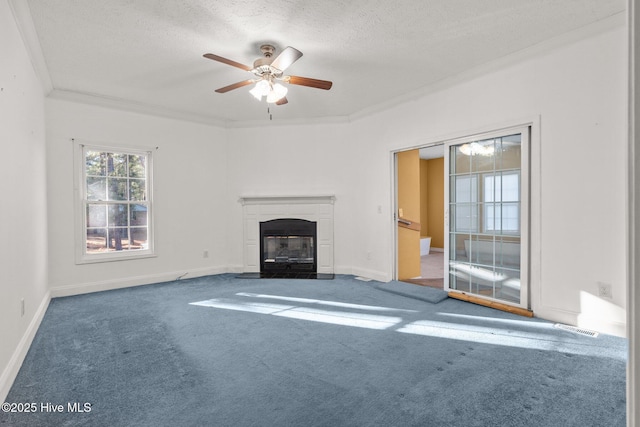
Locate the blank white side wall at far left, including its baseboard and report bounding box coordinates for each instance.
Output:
[0,0,49,401]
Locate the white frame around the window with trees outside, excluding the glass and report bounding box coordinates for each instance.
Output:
[73,140,156,264]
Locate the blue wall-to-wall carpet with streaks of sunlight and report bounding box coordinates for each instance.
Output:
[0,275,627,427]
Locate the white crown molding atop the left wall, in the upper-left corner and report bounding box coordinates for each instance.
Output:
[8,0,53,96]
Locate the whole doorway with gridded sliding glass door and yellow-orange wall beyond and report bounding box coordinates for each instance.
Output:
[395,126,530,309]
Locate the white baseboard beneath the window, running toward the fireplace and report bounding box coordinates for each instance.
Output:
[51,267,228,298]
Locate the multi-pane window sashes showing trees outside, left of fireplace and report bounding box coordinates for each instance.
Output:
[78,145,153,263]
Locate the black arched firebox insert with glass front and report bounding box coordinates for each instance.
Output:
[260,218,318,278]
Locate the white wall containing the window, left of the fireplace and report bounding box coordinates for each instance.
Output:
[46,99,229,296]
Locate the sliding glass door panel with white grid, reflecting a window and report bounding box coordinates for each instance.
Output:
[445,129,529,308]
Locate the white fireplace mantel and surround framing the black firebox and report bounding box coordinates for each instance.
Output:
[239,195,336,274]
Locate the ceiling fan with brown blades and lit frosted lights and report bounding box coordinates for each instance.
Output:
[203,44,333,105]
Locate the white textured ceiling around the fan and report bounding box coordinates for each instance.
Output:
[23,0,626,126]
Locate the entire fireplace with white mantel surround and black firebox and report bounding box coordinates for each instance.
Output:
[239,195,335,279]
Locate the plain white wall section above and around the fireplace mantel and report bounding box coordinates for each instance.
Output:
[227,123,358,274]
